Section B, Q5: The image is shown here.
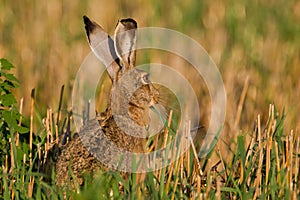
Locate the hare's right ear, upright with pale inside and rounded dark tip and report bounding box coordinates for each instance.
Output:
[114,18,137,70]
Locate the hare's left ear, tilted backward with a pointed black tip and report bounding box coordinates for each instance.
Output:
[83,16,120,81]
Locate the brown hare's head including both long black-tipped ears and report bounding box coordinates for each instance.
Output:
[83,16,158,126]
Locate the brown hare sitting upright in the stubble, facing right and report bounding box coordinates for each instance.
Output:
[55,16,159,188]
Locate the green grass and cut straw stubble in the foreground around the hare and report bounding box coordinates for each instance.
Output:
[0,75,300,199]
